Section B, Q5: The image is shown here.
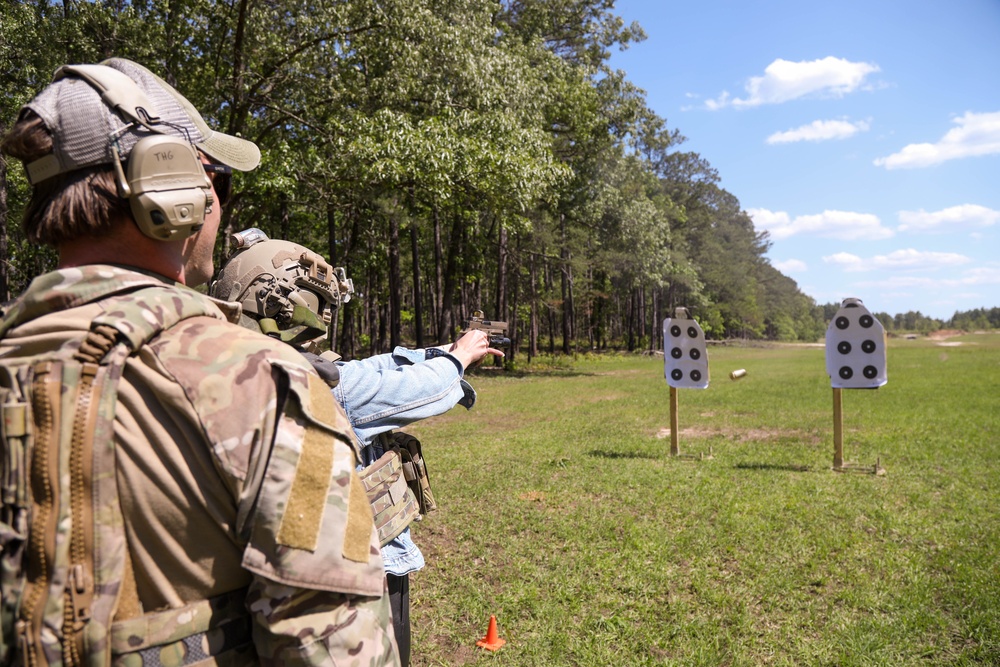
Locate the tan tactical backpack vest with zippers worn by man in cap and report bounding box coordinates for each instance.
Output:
[0,279,250,667]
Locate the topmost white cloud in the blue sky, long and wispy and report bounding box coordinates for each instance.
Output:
[706,56,879,110]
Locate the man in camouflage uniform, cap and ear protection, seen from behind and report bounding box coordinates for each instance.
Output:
[0,59,398,667]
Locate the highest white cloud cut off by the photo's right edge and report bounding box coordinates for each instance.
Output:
[875,111,1000,169]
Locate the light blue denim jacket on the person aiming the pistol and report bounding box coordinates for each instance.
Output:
[333,347,476,576]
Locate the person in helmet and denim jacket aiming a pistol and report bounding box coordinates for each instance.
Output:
[209,234,504,667]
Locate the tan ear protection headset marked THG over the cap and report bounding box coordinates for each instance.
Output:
[53,65,212,241]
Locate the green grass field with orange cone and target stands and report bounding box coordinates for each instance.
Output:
[408,334,1000,667]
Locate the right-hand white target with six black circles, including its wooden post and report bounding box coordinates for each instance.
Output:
[826,298,887,475]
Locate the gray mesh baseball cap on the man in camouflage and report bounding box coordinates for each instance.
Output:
[22,58,260,183]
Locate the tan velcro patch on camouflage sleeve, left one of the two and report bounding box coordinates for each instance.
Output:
[276,422,334,551]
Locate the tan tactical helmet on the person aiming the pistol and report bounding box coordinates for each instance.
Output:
[209,228,354,351]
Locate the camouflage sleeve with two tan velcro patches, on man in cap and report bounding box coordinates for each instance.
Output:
[243,360,398,667]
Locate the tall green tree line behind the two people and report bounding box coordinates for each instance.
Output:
[0,0,988,361]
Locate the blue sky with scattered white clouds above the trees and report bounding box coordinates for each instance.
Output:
[611,0,1000,319]
